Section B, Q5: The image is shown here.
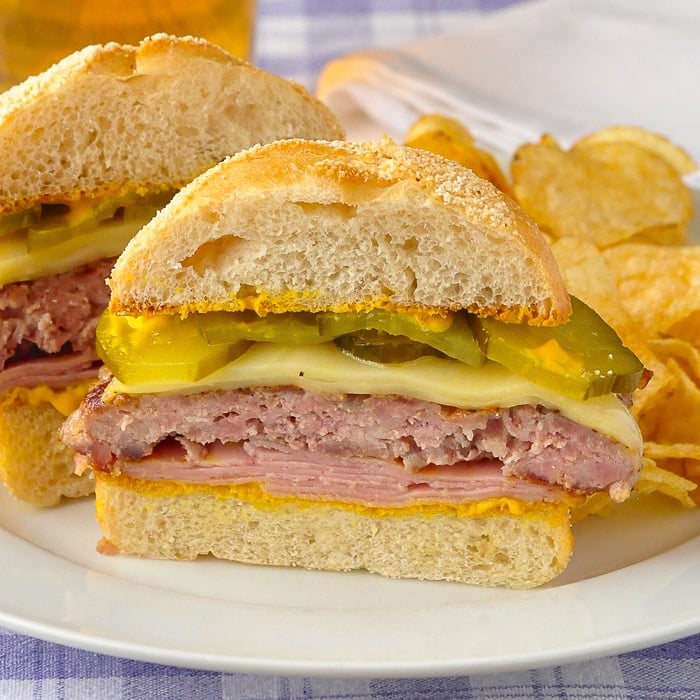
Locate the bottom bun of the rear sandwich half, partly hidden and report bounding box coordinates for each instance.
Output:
[0,393,95,506]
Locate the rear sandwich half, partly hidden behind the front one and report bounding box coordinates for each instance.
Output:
[0,34,342,505]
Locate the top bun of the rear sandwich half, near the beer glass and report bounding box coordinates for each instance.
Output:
[0,34,343,213]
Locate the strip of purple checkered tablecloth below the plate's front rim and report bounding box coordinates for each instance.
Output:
[0,631,700,700]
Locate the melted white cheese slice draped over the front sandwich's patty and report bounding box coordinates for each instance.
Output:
[104,343,642,455]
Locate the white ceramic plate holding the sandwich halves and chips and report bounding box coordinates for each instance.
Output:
[0,190,700,677]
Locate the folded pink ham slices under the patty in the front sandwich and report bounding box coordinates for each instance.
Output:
[110,440,562,507]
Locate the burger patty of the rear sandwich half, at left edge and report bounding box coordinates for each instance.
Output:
[0,260,114,370]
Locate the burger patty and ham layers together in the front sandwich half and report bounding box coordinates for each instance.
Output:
[63,382,639,507]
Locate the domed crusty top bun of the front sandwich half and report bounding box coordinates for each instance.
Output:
[108,139,571,325]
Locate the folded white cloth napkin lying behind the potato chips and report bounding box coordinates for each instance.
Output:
[317,0,700,185]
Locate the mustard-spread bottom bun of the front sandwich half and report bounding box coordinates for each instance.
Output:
[95,473,573,588]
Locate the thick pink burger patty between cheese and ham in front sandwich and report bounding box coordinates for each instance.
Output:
[63,381,639,500]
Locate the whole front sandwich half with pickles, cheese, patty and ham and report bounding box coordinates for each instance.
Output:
[62,139,642,588]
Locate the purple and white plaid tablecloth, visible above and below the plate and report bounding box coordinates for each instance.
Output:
[0,0,700,700]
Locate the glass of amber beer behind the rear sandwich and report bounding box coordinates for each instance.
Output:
[0,0,255,90]
